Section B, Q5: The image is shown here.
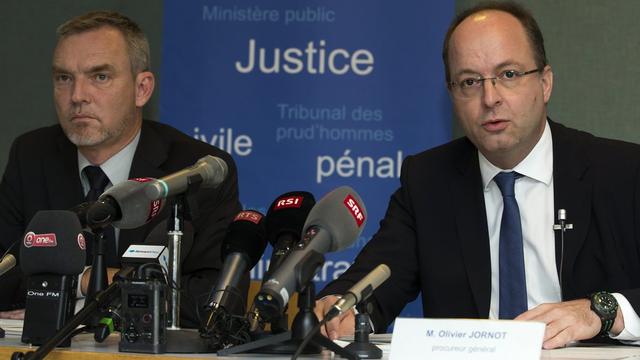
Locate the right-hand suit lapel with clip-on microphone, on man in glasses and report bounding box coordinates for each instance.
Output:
[549,121,592,300]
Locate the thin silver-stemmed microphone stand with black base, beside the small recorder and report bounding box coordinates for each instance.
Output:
[165,174,211,353]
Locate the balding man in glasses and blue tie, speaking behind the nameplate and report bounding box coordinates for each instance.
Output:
[316,3,640,348]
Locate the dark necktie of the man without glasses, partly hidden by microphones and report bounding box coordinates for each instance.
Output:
[82,166,120,267]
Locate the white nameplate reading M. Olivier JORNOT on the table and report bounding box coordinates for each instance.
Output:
[389,318,545,360]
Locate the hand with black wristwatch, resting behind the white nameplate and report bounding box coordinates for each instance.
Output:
[515,299,624,349]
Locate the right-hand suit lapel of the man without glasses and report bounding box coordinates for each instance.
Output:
[118,120,169,253]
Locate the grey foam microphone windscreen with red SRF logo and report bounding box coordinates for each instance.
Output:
[302,186,367,252]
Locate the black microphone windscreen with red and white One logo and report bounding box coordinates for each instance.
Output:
[20,210,86,275]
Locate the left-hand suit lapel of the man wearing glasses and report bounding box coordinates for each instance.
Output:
[451,139,491,318]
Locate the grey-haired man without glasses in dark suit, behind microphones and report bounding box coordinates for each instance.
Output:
[0,12,242,327]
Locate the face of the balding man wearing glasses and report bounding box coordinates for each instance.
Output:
[448,11,553,168]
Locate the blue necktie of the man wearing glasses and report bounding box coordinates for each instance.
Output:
[493,171,527,319]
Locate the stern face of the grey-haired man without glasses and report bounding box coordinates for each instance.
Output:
[53,27,144,148]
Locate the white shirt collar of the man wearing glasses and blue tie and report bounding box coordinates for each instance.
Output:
[478,121,553,191]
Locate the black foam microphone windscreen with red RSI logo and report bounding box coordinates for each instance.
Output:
[266,191,316,247]
